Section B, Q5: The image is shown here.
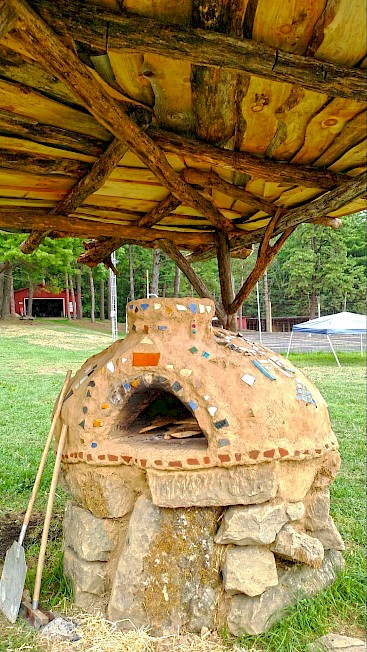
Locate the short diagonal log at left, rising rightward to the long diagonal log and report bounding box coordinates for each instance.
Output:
[20,138,128,254]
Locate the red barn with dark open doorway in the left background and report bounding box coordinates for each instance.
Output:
[14,285,73,317]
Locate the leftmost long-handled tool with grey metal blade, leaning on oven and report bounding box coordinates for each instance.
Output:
[0,371,71,623]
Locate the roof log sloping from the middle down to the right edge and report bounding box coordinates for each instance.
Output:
[148,127,345,190]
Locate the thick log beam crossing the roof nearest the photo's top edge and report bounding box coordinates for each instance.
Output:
[32,0,366,101]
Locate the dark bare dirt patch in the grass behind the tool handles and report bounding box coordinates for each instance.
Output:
[0,512,62,564]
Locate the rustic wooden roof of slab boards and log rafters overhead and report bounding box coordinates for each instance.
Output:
[0,0,367,324]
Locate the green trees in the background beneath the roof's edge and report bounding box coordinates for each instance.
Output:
[0,213,366,321]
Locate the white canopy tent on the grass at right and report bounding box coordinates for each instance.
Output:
[287,312,367,367]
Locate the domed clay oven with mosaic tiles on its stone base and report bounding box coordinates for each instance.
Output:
[59,298,343,634]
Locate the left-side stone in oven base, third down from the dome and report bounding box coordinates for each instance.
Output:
[64,547,108,595]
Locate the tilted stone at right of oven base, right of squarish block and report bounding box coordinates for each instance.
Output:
[270,523,324,568]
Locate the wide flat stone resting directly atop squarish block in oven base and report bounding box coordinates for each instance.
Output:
[215,501,288,546]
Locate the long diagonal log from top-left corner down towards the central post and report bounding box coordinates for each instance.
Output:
[7,0,235,231]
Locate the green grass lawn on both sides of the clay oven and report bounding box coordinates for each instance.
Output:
[0,320,366,652]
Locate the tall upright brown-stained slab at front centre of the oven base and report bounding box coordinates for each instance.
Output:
[108,496,220,633]
